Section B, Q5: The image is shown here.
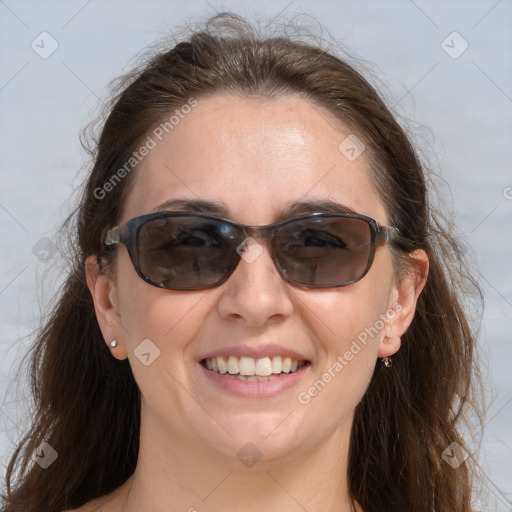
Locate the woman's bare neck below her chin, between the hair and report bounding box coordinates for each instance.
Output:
[113,406,360,512]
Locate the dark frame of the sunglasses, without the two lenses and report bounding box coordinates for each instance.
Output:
[105,210,400,291]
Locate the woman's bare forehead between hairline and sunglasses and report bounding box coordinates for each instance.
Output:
[123,95,386,225]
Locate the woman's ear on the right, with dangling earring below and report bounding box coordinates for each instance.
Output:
[378,249,428,357]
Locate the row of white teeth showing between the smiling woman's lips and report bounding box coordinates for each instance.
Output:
[201,356,310,382]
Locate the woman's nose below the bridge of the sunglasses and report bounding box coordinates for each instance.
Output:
[218,238,293,327]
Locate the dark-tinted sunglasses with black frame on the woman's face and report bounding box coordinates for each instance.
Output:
[105,211,399,290]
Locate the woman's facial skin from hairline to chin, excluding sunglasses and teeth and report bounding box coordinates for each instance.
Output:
[97,95,408,470]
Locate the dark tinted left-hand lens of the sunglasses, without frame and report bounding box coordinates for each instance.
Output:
[137,216,238,290]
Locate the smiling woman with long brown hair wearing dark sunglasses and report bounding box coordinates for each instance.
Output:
[3,15,475,512]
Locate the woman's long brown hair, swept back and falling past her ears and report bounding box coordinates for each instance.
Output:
[2,15,484,512]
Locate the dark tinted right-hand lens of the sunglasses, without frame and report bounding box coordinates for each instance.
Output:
[276,217,372,287]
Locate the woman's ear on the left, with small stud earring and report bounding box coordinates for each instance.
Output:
[85,255,128,360]
